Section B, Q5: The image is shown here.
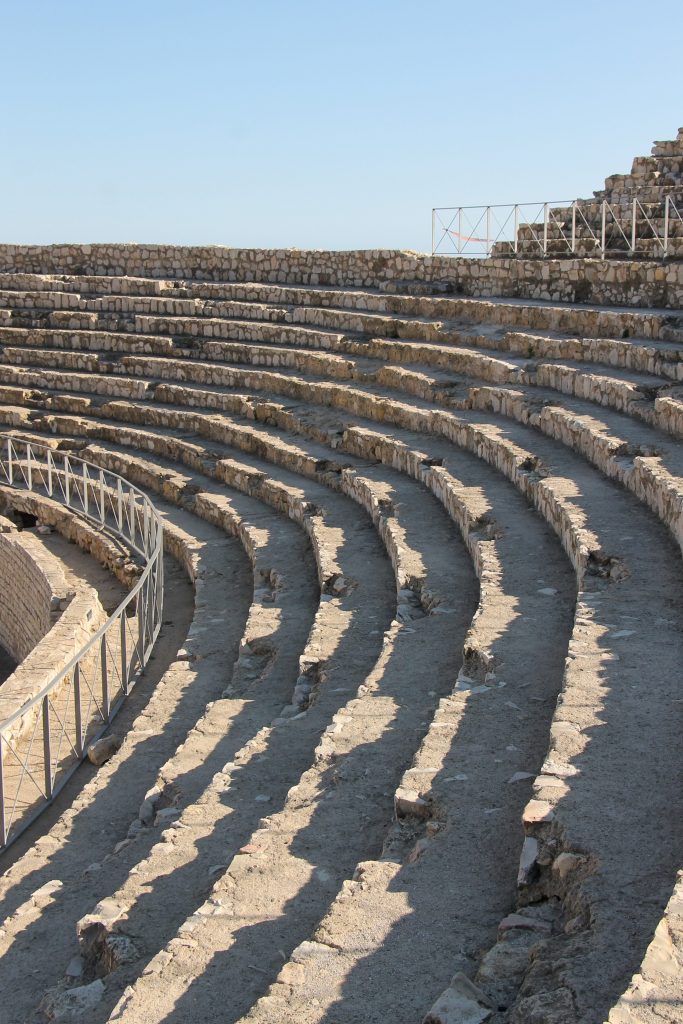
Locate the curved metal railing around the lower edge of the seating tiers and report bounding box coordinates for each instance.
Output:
[0,434,164,850]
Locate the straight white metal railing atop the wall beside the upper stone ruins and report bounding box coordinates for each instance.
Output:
[431,189,683,259]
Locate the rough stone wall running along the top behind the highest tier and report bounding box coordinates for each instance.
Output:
[0,244,683,307]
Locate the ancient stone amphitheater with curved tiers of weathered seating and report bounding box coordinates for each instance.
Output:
[0,129,683,1024]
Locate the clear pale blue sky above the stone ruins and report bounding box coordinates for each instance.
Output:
[0,0,683,251]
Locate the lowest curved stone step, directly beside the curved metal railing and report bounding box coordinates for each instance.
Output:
[0,487,252,1021]
